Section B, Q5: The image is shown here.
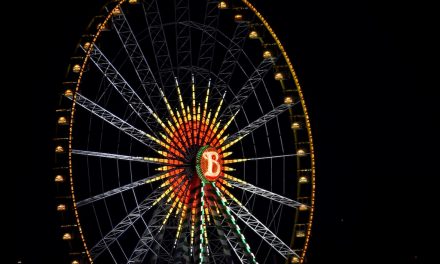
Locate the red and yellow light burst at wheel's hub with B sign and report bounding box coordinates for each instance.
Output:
[139,78,254,263]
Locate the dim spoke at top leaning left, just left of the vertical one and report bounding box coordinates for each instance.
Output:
[142,0,175,89]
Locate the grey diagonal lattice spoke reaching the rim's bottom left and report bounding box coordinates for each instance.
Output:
[90,189,162,259]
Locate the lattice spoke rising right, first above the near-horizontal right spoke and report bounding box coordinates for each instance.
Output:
[221,102,298,151]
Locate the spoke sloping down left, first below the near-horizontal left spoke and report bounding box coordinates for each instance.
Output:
[76,169,182,207]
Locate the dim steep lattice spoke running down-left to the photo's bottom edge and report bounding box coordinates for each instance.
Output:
[127,202,171,264]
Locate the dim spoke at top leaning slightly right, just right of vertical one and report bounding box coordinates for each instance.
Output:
[197,0,219,71]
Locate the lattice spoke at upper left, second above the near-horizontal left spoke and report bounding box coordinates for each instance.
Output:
[86,46,156,125]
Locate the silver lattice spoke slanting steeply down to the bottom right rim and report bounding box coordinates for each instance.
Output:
[229,203,299,259]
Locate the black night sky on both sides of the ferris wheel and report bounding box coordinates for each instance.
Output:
[12,0,440,264]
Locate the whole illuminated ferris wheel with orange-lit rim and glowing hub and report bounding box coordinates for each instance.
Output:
[54,0,315,264]
